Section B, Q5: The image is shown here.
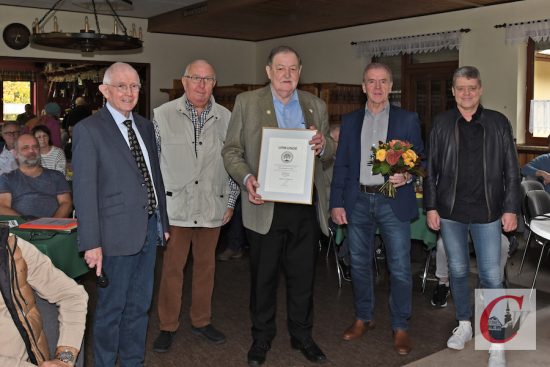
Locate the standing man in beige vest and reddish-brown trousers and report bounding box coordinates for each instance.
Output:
[153,60,239,352]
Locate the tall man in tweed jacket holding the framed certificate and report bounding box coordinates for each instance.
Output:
[222,46,335,366]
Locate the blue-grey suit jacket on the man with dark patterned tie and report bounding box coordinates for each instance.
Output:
[72,107,168,256]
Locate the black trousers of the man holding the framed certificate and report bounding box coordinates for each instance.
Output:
[247,203,319,342]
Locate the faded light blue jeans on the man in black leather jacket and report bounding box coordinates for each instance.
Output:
[441,219,502,321]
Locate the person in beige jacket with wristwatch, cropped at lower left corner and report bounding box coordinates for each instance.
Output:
[0,227,88,367]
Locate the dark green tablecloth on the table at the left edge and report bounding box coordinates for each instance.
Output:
[0,216,89,278]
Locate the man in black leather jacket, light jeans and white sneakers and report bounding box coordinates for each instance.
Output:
[424,66,520,367]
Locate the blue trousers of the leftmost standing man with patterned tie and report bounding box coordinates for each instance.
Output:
[93,215,159,367]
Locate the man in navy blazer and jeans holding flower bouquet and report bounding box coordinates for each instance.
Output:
[330,63,424,355]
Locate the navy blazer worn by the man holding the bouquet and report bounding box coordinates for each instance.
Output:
[330,106,424,221]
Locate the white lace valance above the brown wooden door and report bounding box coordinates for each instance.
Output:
[353,31,461,60]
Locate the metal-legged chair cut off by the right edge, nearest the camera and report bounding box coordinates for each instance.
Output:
[527,190,550,290]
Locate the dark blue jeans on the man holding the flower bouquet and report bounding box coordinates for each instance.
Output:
[348,193,412,330]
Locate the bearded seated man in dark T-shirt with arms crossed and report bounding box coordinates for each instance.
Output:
[0,134,73,218]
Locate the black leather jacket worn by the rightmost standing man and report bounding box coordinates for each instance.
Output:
[424,106,520,222]
